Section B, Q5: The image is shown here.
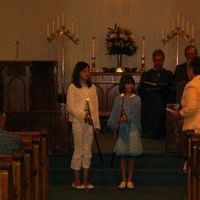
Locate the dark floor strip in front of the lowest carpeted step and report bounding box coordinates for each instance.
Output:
[49,185,186,200]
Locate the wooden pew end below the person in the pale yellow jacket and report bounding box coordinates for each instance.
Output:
[187,132,200,200]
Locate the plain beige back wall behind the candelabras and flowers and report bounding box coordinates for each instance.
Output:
[0,0,200,92]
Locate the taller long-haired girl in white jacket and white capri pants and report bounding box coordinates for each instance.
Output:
[67,62,100,189]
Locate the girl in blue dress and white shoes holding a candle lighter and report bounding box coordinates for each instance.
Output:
[108,75,143,189]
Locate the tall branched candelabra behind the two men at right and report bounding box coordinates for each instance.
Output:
[162,14,194,65]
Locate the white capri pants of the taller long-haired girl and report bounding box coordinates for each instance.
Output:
[71,122,93,170]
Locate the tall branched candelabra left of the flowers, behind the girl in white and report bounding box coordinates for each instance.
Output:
[47,13,79,94]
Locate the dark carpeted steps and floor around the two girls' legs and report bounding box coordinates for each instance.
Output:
[49,134,186,200]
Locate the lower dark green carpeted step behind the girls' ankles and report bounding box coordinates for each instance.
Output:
[49,169,186,186]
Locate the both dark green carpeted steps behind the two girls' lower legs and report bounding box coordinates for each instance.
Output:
[49,153,186,186]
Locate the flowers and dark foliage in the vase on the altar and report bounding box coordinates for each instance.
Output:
[106,24,137,56]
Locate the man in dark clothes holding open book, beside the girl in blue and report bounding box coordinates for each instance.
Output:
[138,49,173,138]
